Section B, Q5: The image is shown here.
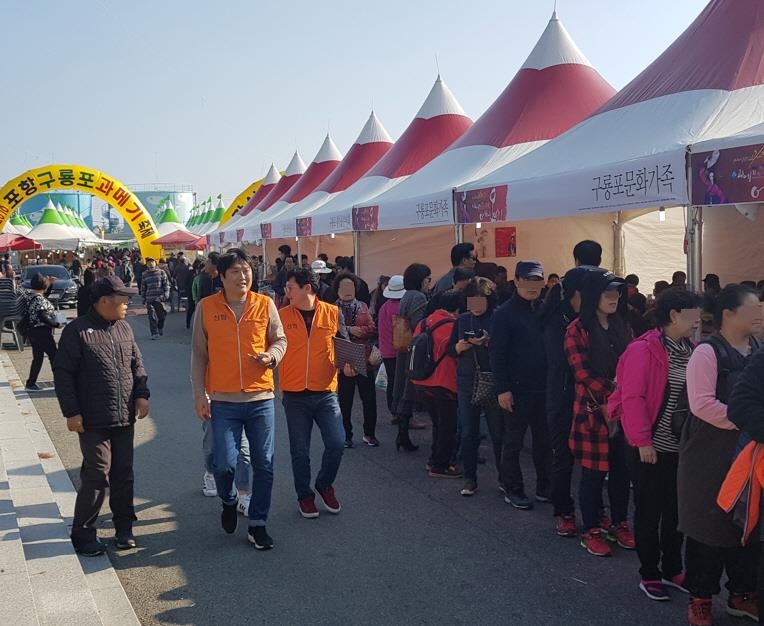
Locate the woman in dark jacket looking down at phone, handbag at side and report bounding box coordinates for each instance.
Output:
[448,278,504,496]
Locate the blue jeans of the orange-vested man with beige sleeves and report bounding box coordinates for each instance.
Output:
[211,399,275,526]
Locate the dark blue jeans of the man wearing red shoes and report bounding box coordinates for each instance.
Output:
[283,391,345,500]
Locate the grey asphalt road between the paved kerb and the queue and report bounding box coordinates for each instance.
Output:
[4,314,740,626]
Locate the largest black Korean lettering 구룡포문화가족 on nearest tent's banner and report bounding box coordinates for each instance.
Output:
[590,162,678,209]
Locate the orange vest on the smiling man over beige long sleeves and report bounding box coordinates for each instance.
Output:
[199,291,274,393]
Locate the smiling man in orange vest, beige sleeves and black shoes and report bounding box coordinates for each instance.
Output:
[191,248,286,550]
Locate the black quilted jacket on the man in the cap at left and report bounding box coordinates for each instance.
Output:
[53,309,150,429]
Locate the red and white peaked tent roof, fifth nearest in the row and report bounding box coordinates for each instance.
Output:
[244,135,342,241]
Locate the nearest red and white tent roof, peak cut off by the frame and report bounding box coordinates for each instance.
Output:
[458,0,764,220]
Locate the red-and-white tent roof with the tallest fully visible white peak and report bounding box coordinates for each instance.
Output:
[369,13,615,228]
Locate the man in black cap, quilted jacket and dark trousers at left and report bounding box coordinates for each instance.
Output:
[53,276,150,556]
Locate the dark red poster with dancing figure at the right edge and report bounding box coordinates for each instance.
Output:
[691,144,764,206]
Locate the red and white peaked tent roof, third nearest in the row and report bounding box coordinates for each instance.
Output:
[304,76,472,235]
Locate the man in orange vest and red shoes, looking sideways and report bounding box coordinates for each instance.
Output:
[279,268,356,518]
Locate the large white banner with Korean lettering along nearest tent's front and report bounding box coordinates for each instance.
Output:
[502,149,688,221]
